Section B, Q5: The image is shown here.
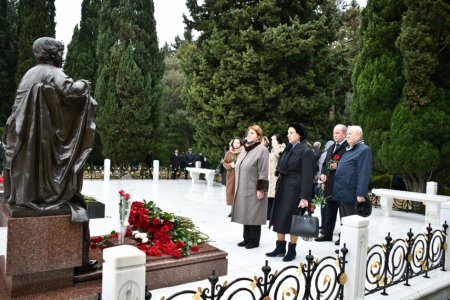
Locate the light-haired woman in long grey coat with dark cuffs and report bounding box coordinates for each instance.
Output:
[231,125,269,249]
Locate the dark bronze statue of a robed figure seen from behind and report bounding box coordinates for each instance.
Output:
[3,37,97,272]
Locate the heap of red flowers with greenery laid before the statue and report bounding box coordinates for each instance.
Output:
[91,192,208,258]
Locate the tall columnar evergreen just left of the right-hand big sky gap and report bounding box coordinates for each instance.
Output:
[95,0,164,164]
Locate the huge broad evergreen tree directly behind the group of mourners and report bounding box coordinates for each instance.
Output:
[182,0,338,160]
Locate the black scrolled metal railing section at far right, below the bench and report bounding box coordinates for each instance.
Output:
[365,222,448,295]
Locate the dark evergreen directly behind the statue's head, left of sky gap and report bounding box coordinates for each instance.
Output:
[16,0,56,81]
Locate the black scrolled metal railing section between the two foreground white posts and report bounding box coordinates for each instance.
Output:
[150,244,348,300]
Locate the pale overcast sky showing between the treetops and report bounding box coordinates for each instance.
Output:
[55,0,366,49]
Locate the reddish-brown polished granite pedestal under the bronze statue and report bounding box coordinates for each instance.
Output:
[0,203,83,297]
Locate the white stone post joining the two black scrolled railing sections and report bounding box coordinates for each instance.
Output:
[341,215,369,300]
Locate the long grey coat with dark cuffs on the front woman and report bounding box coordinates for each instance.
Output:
[231,144,269,225]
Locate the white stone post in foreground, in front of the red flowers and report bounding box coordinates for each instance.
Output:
[102,245,146,300]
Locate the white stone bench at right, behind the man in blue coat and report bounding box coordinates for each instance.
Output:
[372,189,450,225]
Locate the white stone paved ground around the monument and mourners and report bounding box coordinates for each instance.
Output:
[77,180,442,299]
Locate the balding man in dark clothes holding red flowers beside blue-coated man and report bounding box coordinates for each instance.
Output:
[315,124,348,245]
